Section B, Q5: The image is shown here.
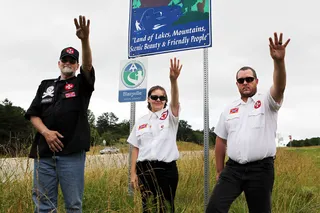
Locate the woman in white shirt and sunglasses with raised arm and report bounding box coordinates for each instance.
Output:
[128,58,182,212]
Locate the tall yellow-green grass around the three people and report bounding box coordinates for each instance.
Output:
[0,142,320,213]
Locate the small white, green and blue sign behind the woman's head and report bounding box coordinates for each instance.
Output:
[119,58,147,102]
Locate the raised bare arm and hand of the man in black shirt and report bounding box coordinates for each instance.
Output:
[74,16,92,77]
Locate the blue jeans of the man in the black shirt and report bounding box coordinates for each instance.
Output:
[32,151,86,213]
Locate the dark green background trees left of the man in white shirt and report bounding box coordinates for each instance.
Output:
[0,99,216,156]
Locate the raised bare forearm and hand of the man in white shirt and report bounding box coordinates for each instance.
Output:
[269,33,290,103]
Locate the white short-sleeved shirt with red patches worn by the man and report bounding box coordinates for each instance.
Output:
[214,91,281,164]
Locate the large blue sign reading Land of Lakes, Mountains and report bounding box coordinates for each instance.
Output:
[128,0,212,58]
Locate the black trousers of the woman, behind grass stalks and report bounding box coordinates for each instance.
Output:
[137,161,179,213]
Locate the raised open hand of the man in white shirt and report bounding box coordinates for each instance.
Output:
[269,33,290,61]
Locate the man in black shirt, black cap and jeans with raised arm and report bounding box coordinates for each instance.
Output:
[25,16,95,213]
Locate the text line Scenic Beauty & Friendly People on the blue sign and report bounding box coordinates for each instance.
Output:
[130,33,209,52]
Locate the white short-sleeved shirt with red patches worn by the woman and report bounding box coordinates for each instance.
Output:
[127,105,180,162]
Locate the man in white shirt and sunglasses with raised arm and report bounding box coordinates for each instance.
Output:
[206,33,290,213]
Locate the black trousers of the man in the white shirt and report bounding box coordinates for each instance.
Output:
[206,157,274,213]
